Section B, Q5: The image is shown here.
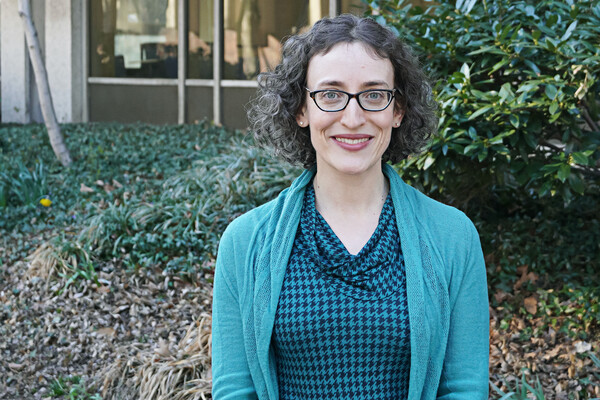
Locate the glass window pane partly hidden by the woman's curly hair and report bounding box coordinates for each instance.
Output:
[223,0,329,79]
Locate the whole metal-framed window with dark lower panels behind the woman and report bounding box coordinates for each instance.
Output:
[86,0,346,128]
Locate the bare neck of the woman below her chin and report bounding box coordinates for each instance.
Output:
[313,164,389,219]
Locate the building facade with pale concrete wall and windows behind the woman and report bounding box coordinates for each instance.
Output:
[0,0,420,128]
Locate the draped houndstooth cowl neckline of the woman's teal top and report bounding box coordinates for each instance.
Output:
[300,185,406,300]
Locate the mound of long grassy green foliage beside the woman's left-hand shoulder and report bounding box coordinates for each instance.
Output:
[80,137,299,272]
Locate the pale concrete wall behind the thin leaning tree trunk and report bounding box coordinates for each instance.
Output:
[0,0,85,123]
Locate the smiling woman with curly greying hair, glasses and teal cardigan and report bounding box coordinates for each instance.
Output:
[212,15,489,400]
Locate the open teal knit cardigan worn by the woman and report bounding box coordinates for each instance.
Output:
[212,164,489,400]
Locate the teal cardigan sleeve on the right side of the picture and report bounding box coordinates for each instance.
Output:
[437,218,489,400]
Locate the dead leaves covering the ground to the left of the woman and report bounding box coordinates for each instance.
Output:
[0,246,212,400]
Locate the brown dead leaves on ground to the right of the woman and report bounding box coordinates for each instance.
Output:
[490,265,600,399]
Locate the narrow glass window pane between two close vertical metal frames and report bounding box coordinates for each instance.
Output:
[187,0,214,79]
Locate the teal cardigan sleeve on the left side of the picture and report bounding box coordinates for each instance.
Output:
[212,224,258,400]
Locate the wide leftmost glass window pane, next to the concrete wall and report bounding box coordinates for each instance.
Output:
[89,0,178,78]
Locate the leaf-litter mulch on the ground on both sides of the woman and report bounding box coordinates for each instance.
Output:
[0,241,600,400]
